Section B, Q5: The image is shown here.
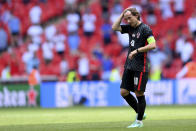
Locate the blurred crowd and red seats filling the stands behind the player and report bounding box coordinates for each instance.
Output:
[0,0,196,82]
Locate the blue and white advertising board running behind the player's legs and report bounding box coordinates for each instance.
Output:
[41,79,196,108]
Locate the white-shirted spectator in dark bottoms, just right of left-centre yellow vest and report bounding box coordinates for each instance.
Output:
[78,53,90,81]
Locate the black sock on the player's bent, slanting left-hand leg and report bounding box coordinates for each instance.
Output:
[123,93,138,113]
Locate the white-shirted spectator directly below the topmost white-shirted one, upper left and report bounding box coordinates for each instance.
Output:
[27,24,43,44]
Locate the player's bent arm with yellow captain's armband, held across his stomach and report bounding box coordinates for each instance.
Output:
[129,35,156,59]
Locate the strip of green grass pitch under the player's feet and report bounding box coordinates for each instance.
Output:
[0,105,196,131]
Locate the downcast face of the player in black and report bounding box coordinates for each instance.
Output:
[124,11,138,27]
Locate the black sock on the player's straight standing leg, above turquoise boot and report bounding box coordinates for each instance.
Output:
[137,95,146,121]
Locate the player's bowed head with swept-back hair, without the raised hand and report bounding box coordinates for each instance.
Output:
[124,8,140,27]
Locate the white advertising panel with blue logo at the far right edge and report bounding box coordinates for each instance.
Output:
[176,79,196,104]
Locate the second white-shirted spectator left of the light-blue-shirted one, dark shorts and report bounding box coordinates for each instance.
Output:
[42,40,54,65]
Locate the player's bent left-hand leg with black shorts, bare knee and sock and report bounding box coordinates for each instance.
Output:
[120,69,138,113]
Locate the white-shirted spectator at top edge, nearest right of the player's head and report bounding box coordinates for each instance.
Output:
[159,0,173,20]
